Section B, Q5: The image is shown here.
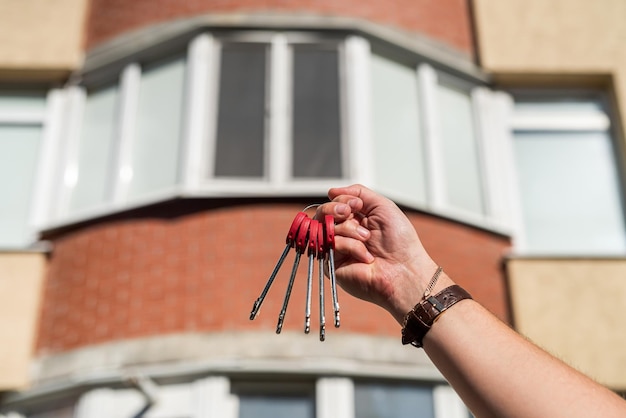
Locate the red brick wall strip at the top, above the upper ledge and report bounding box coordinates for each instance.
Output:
[86,0,474,55]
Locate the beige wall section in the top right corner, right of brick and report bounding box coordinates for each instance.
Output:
[474,0,626,142]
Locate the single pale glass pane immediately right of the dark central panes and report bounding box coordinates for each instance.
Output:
[371,55,426,203]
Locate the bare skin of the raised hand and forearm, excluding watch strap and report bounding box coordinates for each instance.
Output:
[318,185,626,418]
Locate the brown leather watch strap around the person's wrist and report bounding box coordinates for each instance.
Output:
[402,285,472,347]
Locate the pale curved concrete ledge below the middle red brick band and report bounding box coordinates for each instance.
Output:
[3,332,443,406]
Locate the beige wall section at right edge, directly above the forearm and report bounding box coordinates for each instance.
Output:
[507,259,626,390]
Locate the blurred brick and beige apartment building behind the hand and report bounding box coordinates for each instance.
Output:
[0,0,626,418]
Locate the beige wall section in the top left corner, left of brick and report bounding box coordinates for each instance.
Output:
[0,0,87,70]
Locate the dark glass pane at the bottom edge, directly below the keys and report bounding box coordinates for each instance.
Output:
[239,395,315,418]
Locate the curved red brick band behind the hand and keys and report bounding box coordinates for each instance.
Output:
[37,203,509,354]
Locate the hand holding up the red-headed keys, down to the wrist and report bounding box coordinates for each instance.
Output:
[317,185,452,323]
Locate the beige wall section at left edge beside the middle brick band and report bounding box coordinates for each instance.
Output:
[0,253,45,391]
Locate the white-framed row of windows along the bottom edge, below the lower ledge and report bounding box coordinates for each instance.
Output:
[9,374,469,418]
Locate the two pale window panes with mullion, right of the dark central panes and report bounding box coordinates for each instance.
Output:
[370,48,492,223]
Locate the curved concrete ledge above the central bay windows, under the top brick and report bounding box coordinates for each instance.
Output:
[83,13,489,82]
